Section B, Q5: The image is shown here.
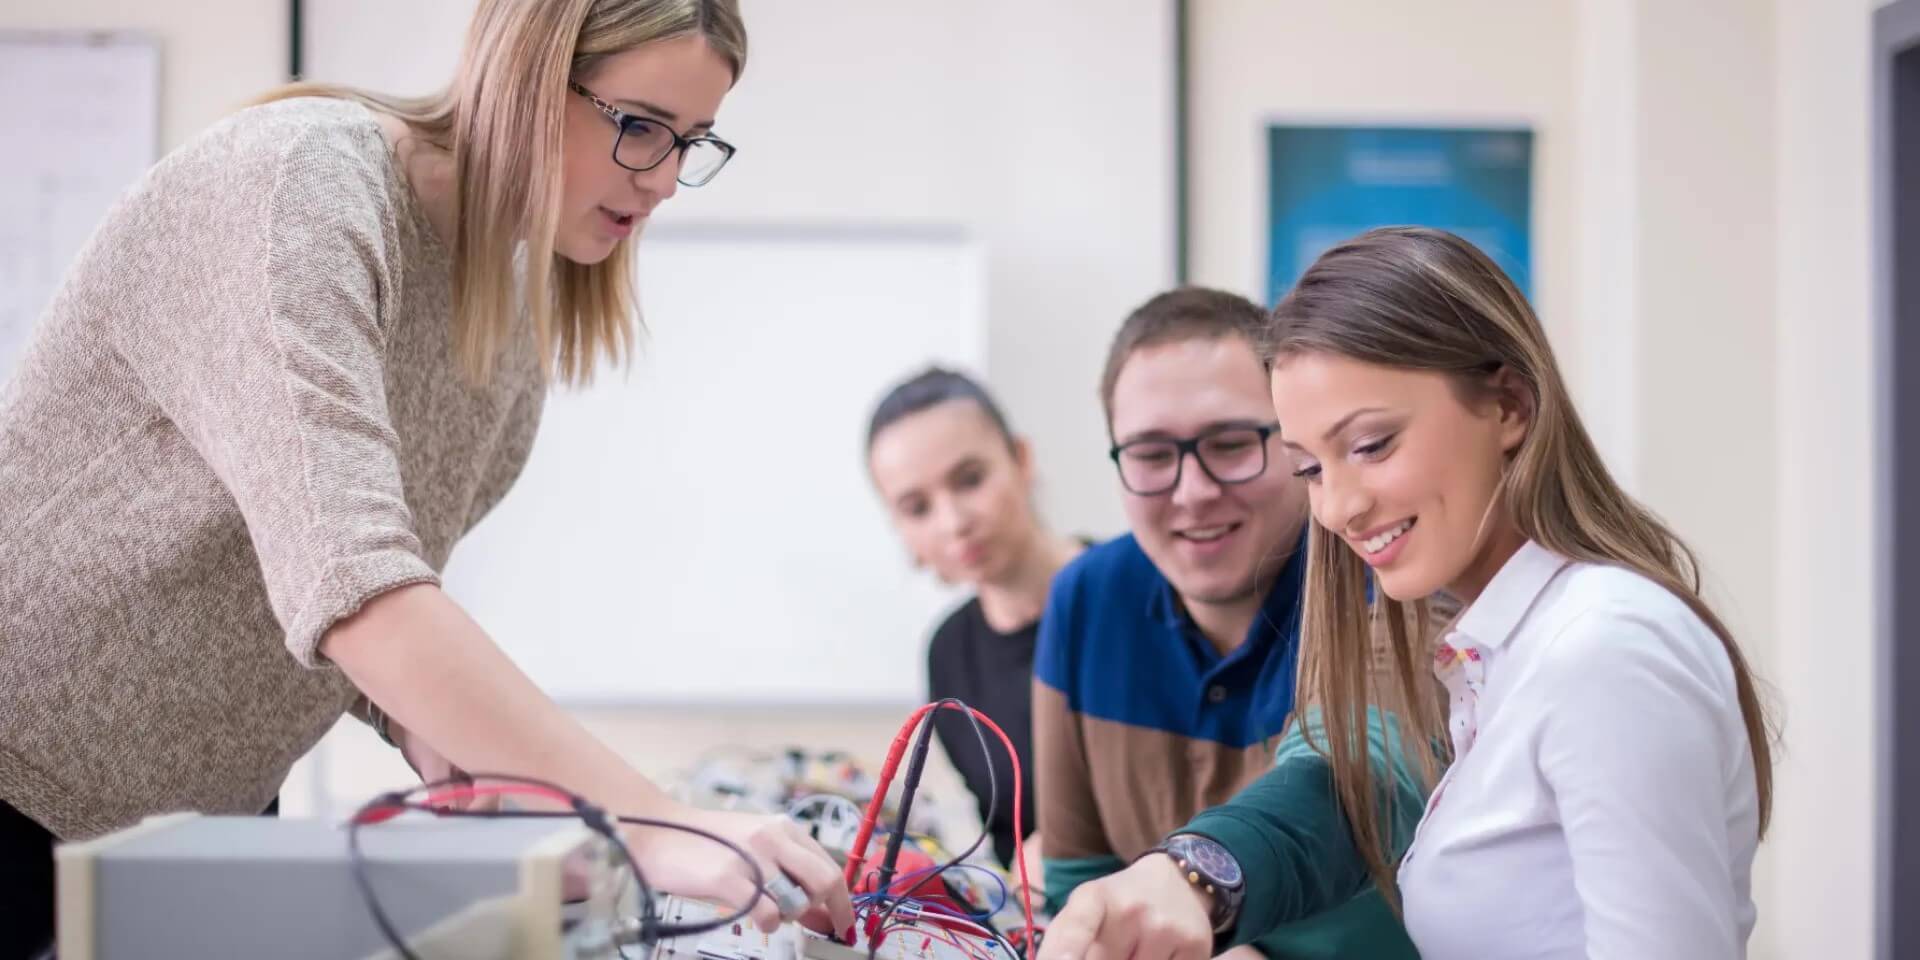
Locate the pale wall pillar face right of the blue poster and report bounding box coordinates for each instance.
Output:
[1628,0,1774,668]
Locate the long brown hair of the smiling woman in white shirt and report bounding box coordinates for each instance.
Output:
[1261,227,1772,906]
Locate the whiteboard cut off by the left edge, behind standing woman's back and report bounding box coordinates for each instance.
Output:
[0,31,159,382]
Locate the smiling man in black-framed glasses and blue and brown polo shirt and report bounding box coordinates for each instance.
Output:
[1033,288,1425,958]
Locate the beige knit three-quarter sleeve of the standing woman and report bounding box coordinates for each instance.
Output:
[113,121,436,666]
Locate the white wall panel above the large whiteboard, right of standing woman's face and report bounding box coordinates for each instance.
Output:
[666,0,1173,536]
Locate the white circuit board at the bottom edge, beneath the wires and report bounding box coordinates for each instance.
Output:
[628,897,1018,960]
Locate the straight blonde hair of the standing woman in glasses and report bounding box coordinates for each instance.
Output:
[257,0,747,384]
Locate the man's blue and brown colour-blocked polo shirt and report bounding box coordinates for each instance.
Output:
[1033,534,1425,958]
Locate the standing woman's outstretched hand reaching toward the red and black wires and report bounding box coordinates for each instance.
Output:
[626,808,852,931]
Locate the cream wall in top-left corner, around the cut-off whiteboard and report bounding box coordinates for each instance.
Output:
[0,0,288,152]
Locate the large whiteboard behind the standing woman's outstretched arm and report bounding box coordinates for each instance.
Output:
[445,225,987,705]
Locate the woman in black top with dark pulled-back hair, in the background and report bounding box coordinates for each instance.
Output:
[866,367,1083,871]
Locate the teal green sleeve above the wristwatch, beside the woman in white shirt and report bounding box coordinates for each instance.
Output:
[1175,708,1427,954]
